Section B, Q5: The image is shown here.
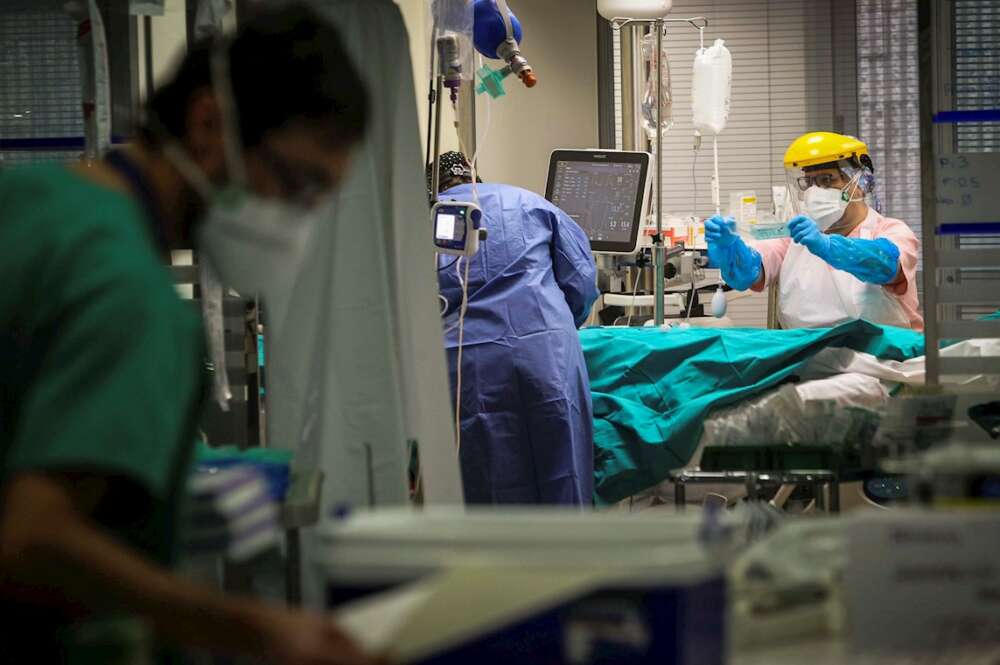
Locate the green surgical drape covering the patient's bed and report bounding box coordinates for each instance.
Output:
[580,321,924,505]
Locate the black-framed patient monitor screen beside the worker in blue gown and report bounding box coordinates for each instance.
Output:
[545,150,649,253]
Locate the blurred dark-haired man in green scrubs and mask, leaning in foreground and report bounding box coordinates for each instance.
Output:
[0,5,380,665]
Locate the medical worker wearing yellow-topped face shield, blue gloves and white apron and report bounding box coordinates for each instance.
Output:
[705,132,924,330]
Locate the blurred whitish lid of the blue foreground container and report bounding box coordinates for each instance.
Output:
[319,508,706,587]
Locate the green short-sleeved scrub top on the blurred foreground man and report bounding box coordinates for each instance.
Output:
[0,164,203,662]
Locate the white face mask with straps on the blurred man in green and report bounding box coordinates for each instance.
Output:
[164,54,320,302]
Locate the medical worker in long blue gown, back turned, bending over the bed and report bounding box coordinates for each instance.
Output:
[428,152,597,506]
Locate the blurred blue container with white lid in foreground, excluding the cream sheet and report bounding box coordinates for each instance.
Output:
[317,508,726,665]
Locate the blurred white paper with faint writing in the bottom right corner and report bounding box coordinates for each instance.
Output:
[844,511,1000,653]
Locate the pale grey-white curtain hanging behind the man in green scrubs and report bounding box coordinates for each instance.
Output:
[265,0,461,516]
